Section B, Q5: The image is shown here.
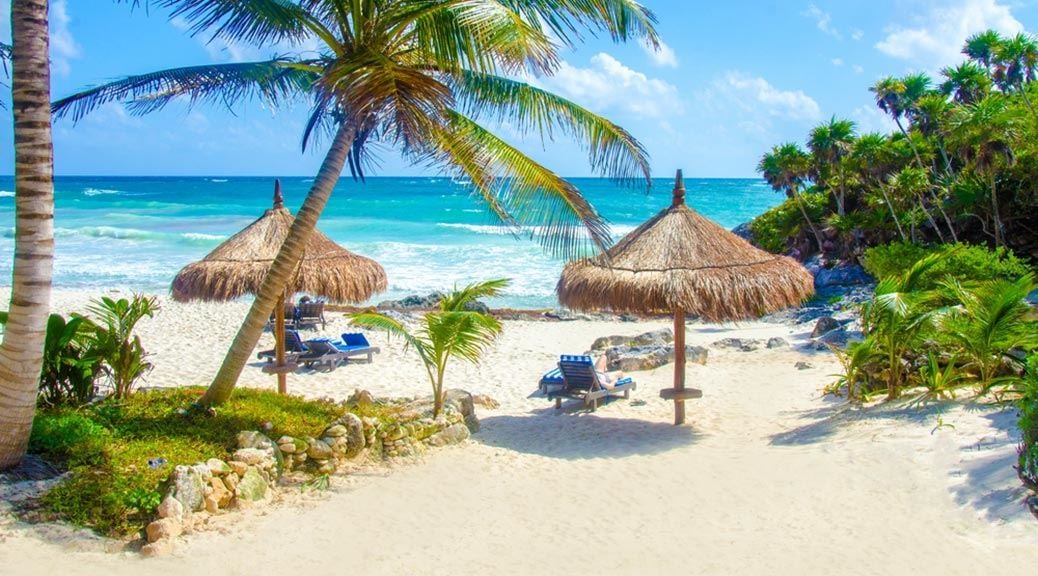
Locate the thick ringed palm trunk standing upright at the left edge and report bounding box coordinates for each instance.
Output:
[0,0,54,470]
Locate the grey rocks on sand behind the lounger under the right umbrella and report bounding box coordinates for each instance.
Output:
[590,328,708,372]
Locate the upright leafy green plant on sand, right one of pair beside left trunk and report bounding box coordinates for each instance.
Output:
[87,294,159,397]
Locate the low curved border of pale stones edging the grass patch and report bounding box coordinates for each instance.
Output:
[141,390,480,556]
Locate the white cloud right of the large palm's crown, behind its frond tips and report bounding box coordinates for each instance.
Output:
[530,52,684,118]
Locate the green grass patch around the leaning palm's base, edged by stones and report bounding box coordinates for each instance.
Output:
[29,388,346,537]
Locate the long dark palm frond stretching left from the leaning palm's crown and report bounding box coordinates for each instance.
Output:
[52,58,317,121]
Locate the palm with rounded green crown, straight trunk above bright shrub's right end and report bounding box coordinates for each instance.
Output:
[949,94,1020,246]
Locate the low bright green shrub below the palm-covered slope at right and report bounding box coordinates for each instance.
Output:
[863,242,1031,287]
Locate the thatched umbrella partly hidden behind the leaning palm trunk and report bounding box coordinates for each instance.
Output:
[172,181,386,393]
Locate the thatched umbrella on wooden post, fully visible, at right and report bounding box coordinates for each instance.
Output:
[556,170,815,424]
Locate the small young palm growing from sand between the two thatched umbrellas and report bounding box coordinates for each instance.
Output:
[352,278,509,418]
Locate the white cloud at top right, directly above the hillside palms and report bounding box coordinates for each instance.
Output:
[876,0,1023,68]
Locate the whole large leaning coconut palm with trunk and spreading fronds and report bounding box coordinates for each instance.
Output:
[55,0,659,404]
